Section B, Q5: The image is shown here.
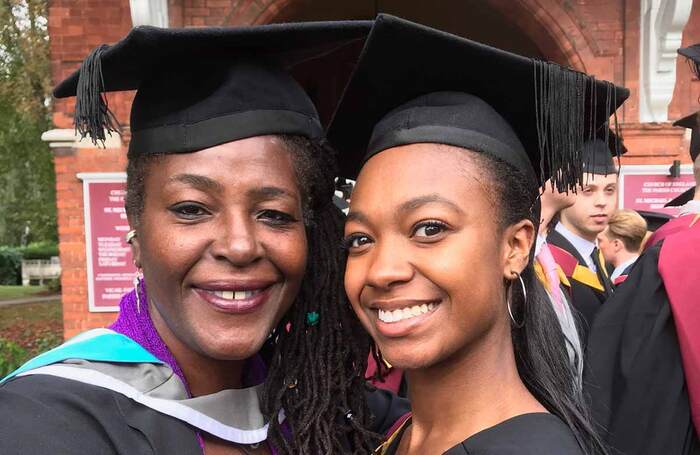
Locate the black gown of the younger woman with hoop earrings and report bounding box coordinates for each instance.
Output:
[376,413,584,455]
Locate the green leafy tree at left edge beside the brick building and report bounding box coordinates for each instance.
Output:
[0,0,57,245]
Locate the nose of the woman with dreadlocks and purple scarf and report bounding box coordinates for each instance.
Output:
[211,214,263,267]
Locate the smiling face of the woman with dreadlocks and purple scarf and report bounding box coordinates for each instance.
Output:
[134,136,307,360]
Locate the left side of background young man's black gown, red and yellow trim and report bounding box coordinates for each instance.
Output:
[547,231,610,342]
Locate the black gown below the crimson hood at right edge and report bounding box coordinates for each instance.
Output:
[584,245,700,455]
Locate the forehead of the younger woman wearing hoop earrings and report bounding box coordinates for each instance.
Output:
[351,144,490,213]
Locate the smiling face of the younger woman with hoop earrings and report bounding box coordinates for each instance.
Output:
[345,144,534,369]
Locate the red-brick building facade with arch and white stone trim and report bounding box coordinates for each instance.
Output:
[44,0,700,337]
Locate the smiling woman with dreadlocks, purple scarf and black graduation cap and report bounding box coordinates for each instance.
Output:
[0,22,404,454]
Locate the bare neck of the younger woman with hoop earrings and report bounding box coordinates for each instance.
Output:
[402,322,545,454]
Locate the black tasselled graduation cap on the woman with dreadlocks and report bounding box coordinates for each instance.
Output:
[54,21,372,156]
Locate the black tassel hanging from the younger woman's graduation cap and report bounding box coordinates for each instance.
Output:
[533,60,619,191]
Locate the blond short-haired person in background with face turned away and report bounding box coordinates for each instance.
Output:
[598,209,647,287]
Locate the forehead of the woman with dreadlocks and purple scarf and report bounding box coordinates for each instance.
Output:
[149,136,298,190]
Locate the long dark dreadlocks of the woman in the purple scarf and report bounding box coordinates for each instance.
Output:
[125,135,380,455]
